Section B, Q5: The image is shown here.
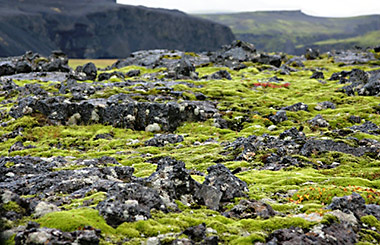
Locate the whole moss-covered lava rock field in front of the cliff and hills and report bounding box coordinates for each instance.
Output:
[0,41,380,245]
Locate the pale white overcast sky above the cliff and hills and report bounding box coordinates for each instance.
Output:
[117,0,380,17]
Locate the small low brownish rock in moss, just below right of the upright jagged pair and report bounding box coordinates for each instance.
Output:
[223,200,276,219]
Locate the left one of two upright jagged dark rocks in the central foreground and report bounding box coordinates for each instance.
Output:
[145,157,200,207]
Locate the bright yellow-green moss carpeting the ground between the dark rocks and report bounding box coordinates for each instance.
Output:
[0,55,380,244]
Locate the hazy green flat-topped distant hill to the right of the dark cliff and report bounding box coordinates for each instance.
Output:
[198,11,380,54]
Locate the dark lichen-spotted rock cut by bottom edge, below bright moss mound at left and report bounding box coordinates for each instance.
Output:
[15,222,101,245]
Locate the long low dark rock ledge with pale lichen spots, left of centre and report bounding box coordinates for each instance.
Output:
[9,96,217,131]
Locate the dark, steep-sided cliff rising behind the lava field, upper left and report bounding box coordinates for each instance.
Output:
[0,0,234,58]
